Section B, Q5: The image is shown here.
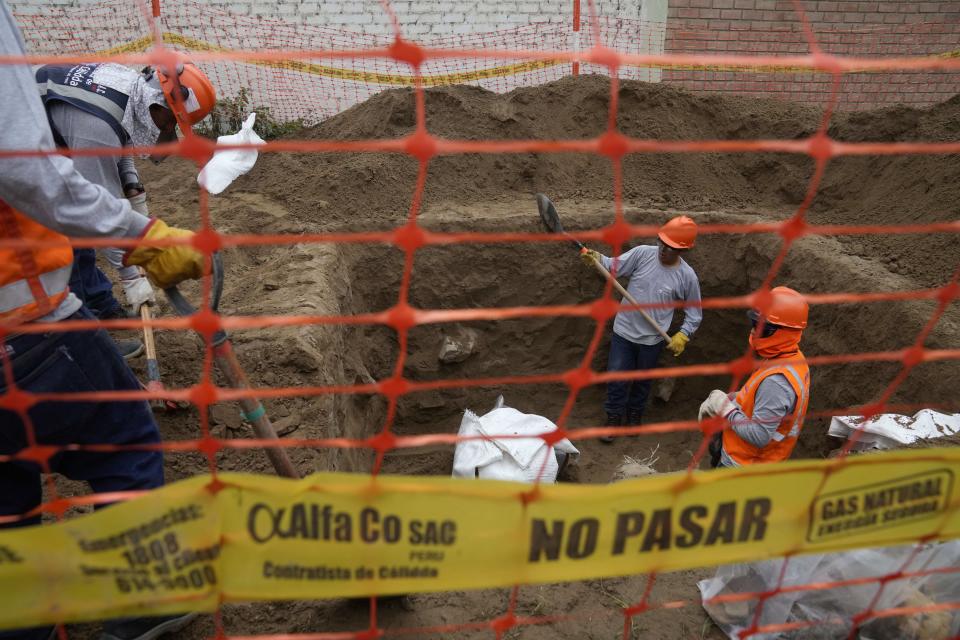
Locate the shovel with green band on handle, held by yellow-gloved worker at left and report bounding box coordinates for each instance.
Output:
[163,253,300,478]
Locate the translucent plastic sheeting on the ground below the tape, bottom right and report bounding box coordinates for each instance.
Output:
[697,540,960,640]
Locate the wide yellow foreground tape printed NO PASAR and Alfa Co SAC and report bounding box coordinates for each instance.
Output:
[0,448,960,628]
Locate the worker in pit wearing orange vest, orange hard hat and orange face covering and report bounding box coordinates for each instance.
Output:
[699,287,810,467]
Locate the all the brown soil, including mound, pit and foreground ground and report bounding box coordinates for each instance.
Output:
[56,76,960,639]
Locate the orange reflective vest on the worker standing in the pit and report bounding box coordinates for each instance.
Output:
[723,352,810,465]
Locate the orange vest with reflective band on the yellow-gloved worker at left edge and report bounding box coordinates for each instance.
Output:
[0,200,73,323]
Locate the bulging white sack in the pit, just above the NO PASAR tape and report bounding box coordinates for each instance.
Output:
[453,399,580,483]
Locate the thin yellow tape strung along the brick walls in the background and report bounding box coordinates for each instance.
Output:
[98,31,960,87]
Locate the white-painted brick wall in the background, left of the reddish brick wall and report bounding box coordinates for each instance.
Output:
[8,0,667,122]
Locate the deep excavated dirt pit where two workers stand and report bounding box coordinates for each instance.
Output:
[344,200,956,482]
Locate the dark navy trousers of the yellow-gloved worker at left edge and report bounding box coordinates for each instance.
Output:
[0,308,163,640]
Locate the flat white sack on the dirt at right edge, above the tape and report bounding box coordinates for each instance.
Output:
[827,409,960,449]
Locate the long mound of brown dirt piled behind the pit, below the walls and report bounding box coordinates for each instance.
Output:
[221,76,960,286]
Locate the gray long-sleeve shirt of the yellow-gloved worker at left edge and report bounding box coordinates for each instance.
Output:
[0,0,149,321]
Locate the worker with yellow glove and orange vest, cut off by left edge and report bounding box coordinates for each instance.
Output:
[0,0,204,640]
